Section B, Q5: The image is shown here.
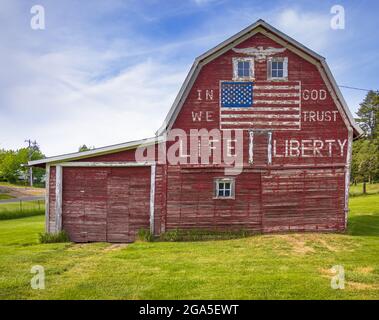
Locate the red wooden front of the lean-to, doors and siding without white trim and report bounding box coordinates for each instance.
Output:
[48,146,166,242]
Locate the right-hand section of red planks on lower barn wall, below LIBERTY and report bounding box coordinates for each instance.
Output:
[262,168,344,232]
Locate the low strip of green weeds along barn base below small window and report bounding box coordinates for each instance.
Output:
[159,229,252,241]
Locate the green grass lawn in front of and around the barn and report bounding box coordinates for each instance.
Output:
[0,194,379,299]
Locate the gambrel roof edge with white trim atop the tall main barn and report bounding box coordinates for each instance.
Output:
[156,19,363,137]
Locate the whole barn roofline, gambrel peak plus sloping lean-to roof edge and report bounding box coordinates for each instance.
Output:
[28,19,363,166]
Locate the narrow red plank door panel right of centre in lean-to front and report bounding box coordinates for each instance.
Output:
[107,168,130,242]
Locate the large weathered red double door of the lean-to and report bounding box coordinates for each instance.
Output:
[62,167,150,242]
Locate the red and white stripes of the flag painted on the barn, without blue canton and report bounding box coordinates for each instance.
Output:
[220,81,301,130]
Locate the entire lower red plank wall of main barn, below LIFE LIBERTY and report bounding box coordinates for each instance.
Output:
[166,166,344,232]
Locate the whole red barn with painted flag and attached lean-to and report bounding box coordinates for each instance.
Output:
[29,20,361,242]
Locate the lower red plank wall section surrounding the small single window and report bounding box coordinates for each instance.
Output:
[166,166,261,231]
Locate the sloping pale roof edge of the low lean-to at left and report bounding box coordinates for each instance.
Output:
[28,137,163,166]
